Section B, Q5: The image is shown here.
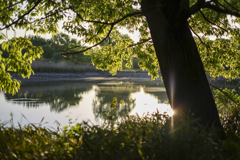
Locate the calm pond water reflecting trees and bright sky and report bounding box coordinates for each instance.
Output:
[0,81,172,128]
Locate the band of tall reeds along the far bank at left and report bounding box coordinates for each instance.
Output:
[32,60,97,73]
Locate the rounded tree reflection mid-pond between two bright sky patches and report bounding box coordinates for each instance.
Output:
[92,83,140,120]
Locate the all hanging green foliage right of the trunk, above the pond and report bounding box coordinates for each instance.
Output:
[188,0,240,79]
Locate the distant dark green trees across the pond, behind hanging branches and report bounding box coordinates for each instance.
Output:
[0,31,139,68]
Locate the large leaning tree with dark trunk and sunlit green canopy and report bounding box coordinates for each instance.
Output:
[0,0,240,131]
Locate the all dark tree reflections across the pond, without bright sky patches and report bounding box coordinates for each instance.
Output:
[5,81,171,120]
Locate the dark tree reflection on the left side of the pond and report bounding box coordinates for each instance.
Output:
[5,82,92,112]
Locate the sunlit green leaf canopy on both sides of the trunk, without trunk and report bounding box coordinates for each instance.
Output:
[0,0,240,93]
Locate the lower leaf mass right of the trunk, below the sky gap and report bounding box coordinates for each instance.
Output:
[196,39,240,79]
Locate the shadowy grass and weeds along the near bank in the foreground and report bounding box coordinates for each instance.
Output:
[0,105,240,160]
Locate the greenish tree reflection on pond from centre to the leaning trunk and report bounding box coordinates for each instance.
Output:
[92,81,168,120]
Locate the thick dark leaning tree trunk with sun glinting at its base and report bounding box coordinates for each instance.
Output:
[141,0,222,130]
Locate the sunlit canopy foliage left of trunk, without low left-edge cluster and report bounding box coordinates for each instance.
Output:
[0,0,159,84]
